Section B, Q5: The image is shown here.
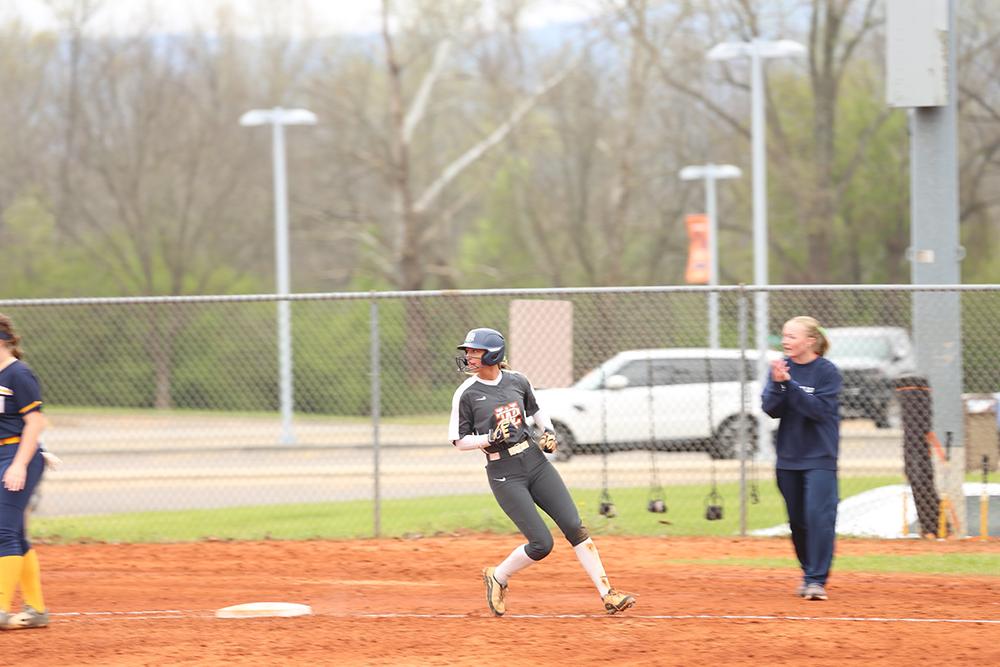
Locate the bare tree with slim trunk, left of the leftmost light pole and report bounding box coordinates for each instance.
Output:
[35,9,292,407]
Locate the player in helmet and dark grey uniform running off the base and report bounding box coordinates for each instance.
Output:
[448,329,635,616]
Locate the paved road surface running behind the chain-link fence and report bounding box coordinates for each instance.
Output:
[37,415,902,516]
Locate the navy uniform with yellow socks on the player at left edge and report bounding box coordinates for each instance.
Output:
[0,360,45,612]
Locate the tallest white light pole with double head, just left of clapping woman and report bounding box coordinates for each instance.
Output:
[708,39,806,451]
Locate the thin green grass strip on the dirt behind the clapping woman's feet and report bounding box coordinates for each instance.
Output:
[667,553,1000,577]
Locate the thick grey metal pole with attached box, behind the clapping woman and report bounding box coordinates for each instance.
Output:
[885,0,968,537]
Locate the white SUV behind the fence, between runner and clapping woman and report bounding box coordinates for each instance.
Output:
[535,348,780,459]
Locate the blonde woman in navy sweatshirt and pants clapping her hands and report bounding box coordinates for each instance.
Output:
[763,317,841,600]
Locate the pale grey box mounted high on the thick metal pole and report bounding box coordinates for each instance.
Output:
[885,0,949,107]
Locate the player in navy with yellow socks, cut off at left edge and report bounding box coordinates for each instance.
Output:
[0,315,49,630]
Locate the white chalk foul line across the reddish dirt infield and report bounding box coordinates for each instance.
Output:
[50,609,1000,625]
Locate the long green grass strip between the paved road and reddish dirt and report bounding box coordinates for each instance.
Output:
[31,477,898,542]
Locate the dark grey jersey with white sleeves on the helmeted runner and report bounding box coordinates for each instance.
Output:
[448,370,538,452]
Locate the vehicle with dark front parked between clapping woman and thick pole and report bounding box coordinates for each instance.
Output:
[826,327,917,428]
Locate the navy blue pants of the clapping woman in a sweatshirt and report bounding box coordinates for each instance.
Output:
[777,469,840,585]
